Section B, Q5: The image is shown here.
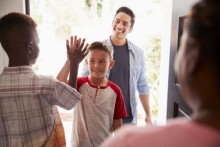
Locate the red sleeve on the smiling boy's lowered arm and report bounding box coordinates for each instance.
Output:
[109,81,127,119]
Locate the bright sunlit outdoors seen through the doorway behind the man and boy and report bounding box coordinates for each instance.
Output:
[29,0,163,143]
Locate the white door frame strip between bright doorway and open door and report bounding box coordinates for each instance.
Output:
[157,0,173,125]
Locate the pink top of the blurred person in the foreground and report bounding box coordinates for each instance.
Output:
[101,118,220,147]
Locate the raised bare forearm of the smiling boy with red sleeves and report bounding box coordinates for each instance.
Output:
[57,60,70,82]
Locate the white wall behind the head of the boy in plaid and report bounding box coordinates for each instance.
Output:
[0,0,25,73]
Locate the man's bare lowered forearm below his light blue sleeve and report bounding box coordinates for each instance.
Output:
[139,94,152,125]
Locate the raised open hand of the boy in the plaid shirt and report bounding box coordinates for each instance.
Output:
[66,36,88,64]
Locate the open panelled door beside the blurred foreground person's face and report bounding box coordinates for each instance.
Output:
[167,0,198,119]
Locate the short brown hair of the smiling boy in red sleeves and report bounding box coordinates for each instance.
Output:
[88,41,114,60]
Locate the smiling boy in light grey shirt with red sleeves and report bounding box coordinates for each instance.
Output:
[57,42,127,147]
